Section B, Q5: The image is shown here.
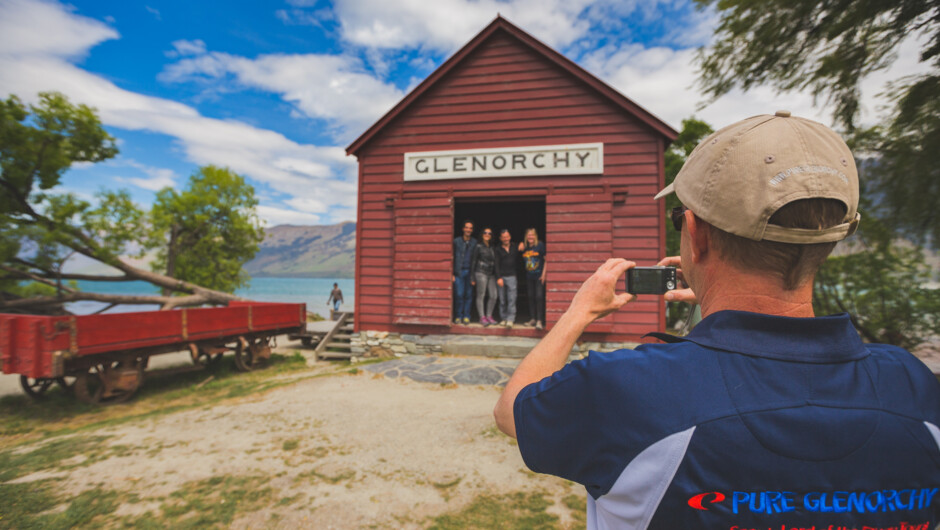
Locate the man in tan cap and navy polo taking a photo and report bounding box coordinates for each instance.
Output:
[495,111,940,530]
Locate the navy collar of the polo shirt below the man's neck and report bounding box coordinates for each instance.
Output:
[650,311,869,363]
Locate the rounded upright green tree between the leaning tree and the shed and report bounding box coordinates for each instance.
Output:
[151,166,264,294]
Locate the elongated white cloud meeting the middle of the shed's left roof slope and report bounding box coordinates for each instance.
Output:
[159,52,404,141]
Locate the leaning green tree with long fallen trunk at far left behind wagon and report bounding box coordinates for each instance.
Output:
[0,92,248,312]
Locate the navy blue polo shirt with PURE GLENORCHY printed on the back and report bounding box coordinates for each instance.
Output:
[514,311,940,530]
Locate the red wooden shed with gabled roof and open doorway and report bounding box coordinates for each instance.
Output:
[346,17,677,342]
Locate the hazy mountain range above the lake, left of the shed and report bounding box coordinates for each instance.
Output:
[244,221,356,278]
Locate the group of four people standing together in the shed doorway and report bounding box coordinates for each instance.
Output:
[454,220,545,329]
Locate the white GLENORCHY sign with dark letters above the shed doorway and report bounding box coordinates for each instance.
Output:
[405,143,604,181]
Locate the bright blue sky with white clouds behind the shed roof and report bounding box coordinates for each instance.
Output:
[0,0,917,226]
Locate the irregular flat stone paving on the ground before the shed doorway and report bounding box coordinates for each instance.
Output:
[364,355,519,386]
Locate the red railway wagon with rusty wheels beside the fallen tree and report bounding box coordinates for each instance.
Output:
[0,302,306,403]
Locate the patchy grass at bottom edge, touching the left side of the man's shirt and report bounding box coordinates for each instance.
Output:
[429,492,559,530]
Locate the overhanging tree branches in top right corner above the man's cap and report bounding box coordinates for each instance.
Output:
[696,0,940,242]
